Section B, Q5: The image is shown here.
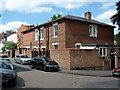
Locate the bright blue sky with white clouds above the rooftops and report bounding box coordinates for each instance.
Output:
[0,0,119,34]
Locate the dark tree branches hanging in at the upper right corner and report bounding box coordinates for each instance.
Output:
[110,1,120,29]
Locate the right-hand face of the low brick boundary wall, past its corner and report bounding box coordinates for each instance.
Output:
[70,49,104,68]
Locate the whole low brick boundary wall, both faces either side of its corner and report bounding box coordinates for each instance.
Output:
[50,49,110,69]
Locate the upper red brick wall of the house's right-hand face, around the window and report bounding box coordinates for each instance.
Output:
[65,20,114,48]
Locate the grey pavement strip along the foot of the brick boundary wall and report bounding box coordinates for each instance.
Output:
[59,68,112,77]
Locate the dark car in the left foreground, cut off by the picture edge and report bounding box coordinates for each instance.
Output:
[0,61,17,86]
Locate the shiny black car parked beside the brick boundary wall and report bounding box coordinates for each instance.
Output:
[30,57,59,71]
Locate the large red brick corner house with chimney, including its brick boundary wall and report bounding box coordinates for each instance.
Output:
[16,12,120,69]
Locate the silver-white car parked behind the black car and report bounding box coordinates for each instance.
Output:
[14,54,31,65]
